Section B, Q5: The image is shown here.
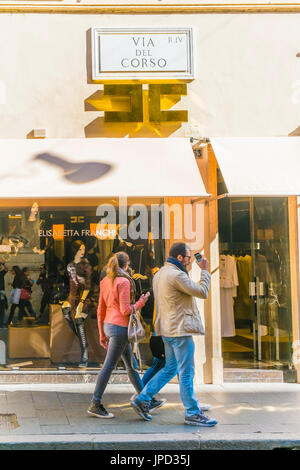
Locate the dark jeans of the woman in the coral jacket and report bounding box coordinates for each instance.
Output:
[93,323,144,402]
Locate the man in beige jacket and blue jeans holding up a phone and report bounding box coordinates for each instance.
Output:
[131,243,217,426]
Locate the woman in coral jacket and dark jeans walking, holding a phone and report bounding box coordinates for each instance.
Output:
[87,252,150,418]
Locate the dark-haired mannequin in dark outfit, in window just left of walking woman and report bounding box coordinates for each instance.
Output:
[62,240,93,367]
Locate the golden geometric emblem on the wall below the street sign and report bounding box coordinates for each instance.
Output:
[85,83,188,137]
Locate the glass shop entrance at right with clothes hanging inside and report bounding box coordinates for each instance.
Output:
[219,197,292,368]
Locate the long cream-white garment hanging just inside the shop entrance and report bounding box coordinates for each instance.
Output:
[220,255,239,338]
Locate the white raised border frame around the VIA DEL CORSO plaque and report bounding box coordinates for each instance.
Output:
[92,27,194,81]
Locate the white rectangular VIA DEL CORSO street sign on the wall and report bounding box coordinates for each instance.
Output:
[92,28,194,80]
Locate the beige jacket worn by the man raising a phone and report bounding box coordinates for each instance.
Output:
[153,262,210,337]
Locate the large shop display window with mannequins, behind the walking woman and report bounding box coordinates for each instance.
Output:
[0,202,164,368]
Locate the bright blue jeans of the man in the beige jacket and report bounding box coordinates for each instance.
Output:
[137,336,201,416]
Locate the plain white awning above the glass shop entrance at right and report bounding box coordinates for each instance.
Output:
[210,137,300,196]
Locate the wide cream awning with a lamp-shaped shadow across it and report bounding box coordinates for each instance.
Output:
[0,138,208,198]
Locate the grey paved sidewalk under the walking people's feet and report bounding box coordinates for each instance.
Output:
[0,383,300,450]
